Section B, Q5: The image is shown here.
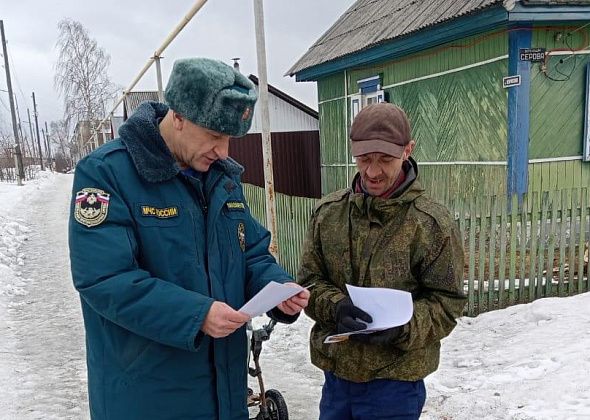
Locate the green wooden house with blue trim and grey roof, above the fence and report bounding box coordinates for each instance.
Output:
[288,0,590,201]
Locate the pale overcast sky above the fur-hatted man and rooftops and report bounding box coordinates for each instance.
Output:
[0,0,355,132]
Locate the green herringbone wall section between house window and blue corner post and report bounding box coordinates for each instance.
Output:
[387,60,507,162]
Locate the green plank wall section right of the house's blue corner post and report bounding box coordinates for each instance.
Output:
[529,25,590,192]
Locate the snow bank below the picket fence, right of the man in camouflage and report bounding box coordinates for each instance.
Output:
[423,293,590,420]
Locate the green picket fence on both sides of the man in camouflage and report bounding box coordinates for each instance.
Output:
[244,185,590,316]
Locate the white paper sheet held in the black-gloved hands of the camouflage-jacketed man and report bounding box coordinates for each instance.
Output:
[324,284,414,343]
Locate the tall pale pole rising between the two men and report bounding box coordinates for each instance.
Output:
[254,0,279,257]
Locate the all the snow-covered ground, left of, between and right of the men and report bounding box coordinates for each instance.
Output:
[0,172,590,420]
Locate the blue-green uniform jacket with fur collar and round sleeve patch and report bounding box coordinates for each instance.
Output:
[69,103,291,420]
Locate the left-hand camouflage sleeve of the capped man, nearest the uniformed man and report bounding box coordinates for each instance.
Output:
[297,213,345,330]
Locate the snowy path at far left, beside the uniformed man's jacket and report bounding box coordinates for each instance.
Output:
[0,172,88,420]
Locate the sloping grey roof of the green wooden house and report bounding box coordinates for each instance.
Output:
[287,0,503,76]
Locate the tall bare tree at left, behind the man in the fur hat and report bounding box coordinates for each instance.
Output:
[54,19,116,144]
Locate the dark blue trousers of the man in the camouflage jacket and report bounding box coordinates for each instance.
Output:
[320,372,426,420]
